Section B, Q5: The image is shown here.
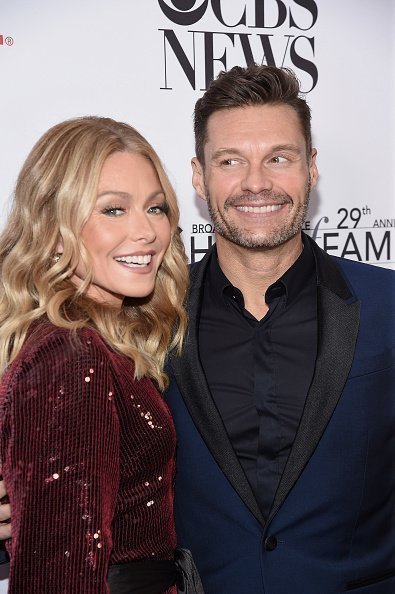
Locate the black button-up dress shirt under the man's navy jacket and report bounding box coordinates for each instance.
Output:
[199,242,317,516]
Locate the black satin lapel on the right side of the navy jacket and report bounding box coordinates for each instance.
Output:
[269,286,360,519]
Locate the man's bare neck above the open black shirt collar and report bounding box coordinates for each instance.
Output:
[216,234,303,320]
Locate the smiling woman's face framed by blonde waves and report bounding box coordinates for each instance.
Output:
[73,152,170,307]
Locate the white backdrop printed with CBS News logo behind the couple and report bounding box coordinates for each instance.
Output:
[0,0,395,593]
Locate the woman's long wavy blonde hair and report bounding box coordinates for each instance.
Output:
[0,117,188,389]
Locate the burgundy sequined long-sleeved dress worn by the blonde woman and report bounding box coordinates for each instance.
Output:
[0,322,176,594]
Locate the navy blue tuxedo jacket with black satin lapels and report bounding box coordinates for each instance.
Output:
[167,237,395,594]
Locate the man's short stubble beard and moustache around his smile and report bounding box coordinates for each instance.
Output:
[206,179,311,249]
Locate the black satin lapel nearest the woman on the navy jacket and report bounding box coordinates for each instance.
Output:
[169,254,264,523]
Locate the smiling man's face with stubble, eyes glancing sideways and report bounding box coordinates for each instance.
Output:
[192,105,318,248]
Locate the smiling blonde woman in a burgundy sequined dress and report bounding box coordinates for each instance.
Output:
[0,117,200,594]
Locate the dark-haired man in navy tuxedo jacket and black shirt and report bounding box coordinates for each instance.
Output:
[167,66,395,594]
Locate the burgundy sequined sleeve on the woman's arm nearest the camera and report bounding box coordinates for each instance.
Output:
[1,331,119,594]
